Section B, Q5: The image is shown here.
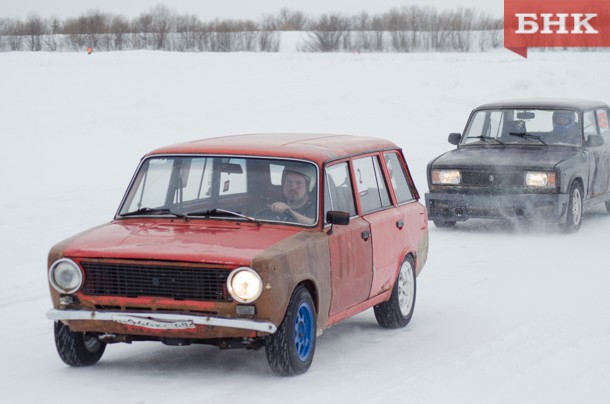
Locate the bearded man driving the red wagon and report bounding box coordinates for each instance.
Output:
[271,165,316,224]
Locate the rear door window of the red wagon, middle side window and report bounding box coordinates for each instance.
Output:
[354,156,391,213]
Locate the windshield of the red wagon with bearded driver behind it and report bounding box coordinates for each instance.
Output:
[118,156,318,225]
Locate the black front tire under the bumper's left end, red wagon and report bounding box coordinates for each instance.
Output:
[55,321,106,367]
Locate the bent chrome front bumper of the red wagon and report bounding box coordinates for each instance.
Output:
[47,309,277,334]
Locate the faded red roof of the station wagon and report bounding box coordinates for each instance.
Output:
[148,133,398,163]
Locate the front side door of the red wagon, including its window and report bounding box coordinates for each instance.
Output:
[324,161,373,316]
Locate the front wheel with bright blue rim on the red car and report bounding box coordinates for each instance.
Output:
[265,286,317,376]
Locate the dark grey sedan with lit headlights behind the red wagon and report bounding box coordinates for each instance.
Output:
[426,99,610,233]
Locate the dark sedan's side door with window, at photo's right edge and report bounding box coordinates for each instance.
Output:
[583,109,610,198]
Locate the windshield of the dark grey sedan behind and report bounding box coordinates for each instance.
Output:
[462,109,582,146]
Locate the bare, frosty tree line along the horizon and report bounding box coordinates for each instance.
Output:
[0,4,503,52]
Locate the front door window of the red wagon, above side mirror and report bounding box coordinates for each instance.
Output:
[324,163,356,218]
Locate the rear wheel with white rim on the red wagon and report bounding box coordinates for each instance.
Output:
[374,256,417,328]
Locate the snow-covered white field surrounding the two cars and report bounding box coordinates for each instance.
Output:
[0,50,610,404]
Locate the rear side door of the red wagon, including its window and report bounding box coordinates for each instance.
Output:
[353,154,404,297]
